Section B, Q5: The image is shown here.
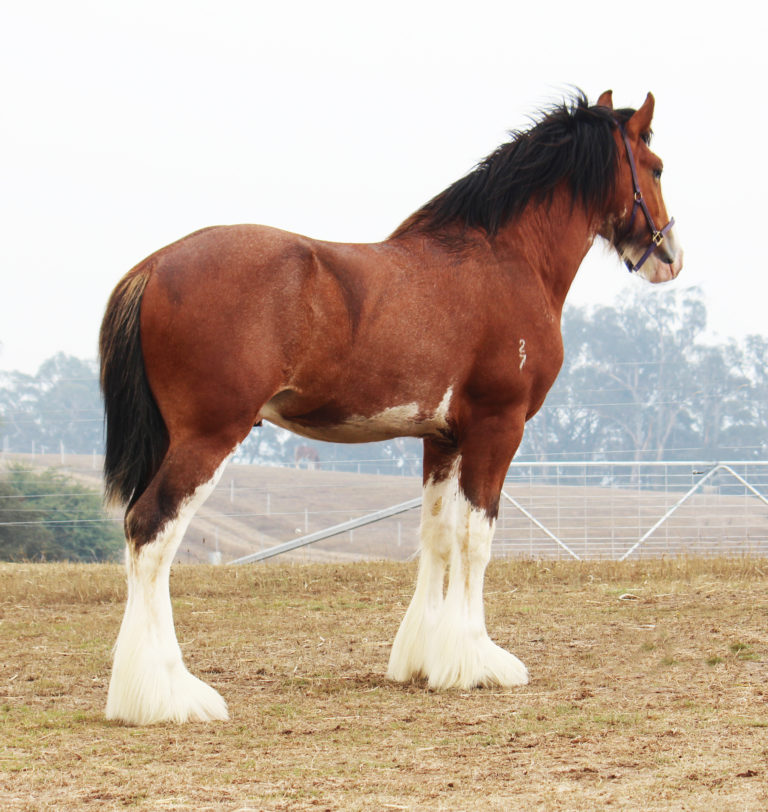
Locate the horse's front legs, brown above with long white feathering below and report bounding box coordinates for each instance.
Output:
[388,420,528,688]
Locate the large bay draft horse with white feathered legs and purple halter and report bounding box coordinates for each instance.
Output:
[100,91,682,724]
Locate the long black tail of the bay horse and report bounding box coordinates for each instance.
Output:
[99,263,168,504]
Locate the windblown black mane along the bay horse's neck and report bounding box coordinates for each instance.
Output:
[394,91,635,236]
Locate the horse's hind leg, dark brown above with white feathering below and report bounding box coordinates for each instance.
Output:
[107,438,234,724]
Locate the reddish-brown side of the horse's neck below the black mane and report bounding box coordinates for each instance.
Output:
[492,193,598,314]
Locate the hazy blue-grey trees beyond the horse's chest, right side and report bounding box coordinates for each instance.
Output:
[521,289,768,460]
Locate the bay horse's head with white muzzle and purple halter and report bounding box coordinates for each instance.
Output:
[597,90,683,282]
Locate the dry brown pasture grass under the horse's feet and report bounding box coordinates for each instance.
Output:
[0,559,768,810]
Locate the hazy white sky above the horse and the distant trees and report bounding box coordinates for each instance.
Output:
[0,0,768,372]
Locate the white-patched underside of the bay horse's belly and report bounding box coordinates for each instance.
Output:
[261,389,452,443]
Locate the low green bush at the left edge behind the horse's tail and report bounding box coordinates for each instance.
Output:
[0,465,123,561]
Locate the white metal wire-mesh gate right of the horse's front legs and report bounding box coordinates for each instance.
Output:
[495,461,768,559]
